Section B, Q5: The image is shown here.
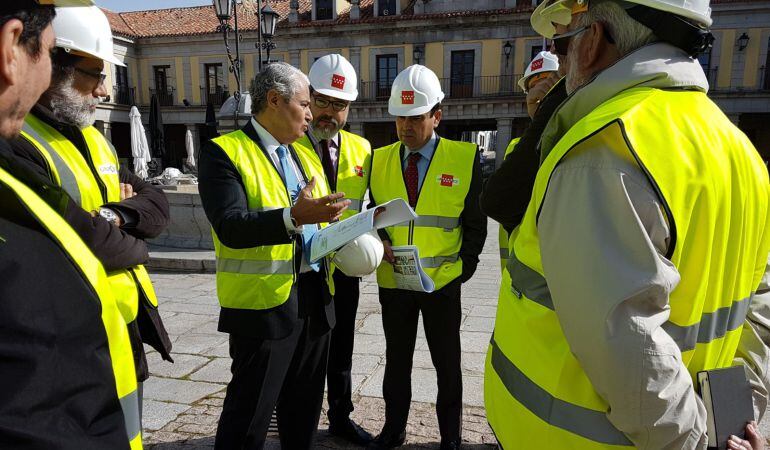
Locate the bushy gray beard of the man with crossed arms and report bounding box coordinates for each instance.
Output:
[47,72,101,129]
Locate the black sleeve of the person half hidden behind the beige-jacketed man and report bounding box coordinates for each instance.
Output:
[480,78,567,233]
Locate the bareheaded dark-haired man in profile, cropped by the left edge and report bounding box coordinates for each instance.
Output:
[0,0,142,450]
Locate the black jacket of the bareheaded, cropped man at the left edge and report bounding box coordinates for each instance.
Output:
[0,140,129,450]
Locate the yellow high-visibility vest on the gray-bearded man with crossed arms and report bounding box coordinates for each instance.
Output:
[21,114,158,323]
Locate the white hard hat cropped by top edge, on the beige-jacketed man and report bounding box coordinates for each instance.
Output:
[530,0,712,39]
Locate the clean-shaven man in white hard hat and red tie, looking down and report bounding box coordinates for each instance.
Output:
[370,65,487,449]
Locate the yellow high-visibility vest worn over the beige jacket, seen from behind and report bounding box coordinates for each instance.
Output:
[484,88,770,449]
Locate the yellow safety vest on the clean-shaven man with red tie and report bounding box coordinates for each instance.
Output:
[370,138,478,289]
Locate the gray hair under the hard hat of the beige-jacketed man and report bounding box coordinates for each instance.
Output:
[577,0,658,56]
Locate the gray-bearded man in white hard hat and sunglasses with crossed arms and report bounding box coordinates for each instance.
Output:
[13,6,171,414]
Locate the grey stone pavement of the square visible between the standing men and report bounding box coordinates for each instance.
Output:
[143,221,500,450]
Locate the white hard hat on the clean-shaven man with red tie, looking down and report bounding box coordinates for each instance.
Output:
[388,64,444,117]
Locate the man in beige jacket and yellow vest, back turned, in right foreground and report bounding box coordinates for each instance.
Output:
[484,0,770,449]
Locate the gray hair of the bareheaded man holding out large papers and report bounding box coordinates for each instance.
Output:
[251,62,310,114]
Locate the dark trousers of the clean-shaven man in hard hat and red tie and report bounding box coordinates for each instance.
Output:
[380,279,463,441]
